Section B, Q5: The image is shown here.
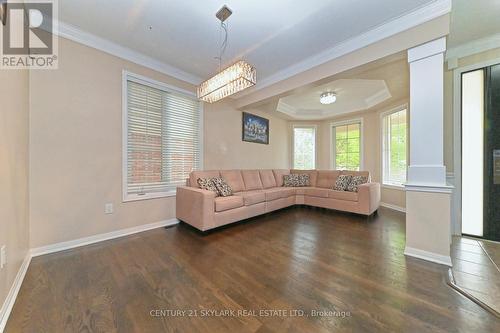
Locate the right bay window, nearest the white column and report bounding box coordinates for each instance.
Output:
[382,108,407,186]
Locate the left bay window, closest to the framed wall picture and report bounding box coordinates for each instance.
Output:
[293,126,316,170]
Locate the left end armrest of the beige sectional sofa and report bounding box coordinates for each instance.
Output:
[175,186,215,231]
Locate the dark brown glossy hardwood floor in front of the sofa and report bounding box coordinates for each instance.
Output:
[6,207,500,333]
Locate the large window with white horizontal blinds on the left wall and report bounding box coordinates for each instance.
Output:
[123,73,202,201]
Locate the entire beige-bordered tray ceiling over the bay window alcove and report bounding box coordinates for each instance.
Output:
[256,52,410,120]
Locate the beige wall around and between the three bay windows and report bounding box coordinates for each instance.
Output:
[289,100,409,208]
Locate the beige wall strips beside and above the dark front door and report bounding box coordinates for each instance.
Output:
[444,48,500,172]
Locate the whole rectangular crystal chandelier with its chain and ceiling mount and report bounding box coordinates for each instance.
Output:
[198,6,257,103]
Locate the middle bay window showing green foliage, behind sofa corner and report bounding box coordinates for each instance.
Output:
[332,120,362,171]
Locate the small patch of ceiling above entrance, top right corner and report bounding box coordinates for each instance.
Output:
[448,0,500,48]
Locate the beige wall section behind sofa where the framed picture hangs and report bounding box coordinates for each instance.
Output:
[204,99,290,169]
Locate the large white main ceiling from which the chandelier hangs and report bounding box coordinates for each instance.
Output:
[59,0,438,80]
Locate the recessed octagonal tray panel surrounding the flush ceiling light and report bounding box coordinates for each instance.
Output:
[276,79,391,120]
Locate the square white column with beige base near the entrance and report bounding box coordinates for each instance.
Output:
[405,37,452,266]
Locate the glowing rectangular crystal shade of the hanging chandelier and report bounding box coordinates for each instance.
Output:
[198,60,257,103]
